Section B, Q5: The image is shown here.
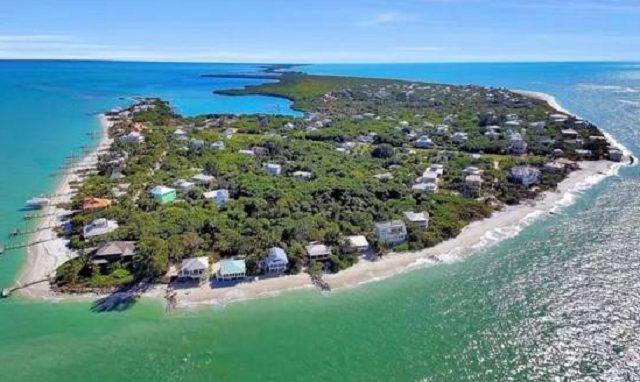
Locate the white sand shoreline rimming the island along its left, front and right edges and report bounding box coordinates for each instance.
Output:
[13,91,628,308]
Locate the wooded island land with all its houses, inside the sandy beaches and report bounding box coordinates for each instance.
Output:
[13,66,623,300]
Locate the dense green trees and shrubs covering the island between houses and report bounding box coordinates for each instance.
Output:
[57,74,608,288]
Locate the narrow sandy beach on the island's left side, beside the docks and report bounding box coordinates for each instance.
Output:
[16,115,112,298]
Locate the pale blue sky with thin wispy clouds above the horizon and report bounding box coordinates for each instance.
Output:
[0,0,640,63]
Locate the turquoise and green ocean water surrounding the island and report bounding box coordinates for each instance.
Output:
[0,61,640,381]
